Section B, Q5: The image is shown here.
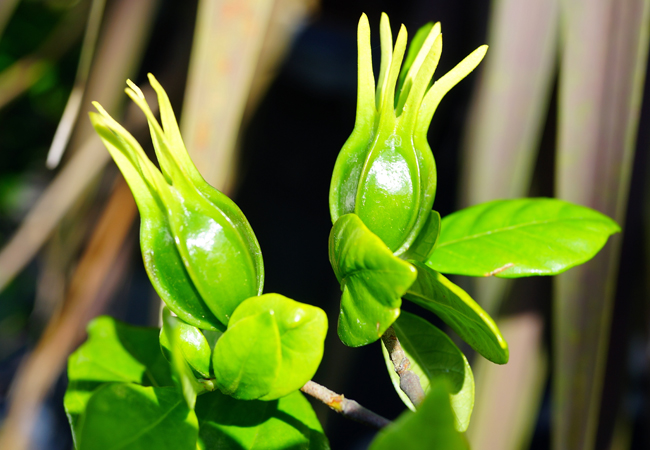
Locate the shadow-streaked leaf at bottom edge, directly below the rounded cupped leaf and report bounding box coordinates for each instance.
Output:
[196,391,329,450]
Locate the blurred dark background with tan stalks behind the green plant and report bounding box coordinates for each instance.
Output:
[0,0,650,450]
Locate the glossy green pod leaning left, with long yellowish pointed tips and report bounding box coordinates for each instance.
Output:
[90,75,264,330]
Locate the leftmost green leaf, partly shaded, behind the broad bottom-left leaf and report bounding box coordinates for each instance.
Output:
[63,316,174,440]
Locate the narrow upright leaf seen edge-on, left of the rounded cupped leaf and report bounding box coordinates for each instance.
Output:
[161,308,205,409]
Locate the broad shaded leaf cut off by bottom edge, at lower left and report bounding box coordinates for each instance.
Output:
[77,383,198,450]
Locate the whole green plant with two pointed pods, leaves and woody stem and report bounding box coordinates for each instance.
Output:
[65,15,619,450]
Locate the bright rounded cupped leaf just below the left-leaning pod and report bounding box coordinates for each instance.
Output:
[212,294,327,400]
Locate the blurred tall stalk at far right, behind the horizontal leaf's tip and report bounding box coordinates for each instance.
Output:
[553,0,650,450]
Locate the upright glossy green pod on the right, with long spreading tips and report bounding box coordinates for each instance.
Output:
[329,14,487,259]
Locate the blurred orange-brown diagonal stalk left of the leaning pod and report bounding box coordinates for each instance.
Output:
[0,178,137,450]
